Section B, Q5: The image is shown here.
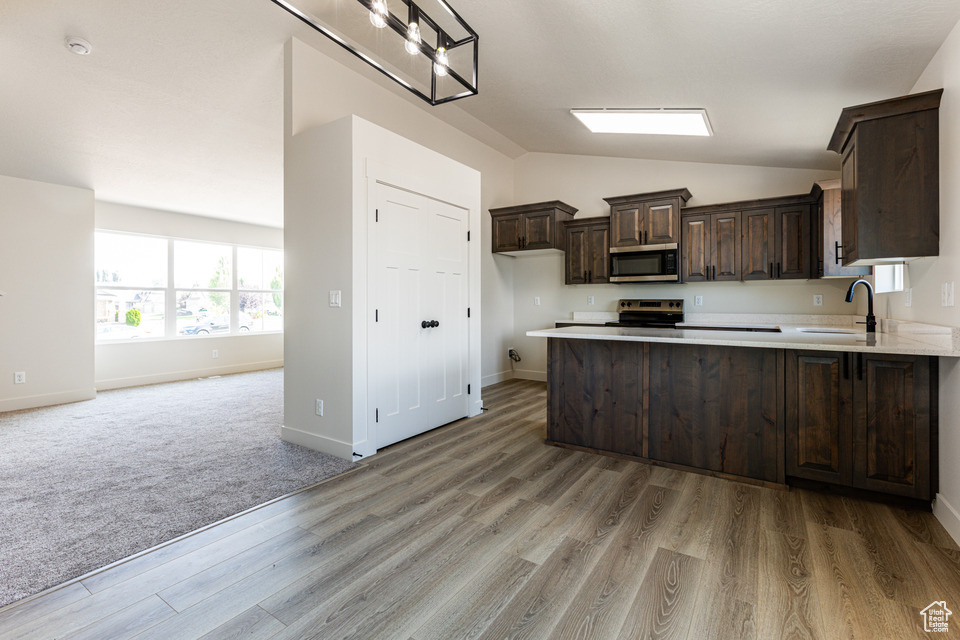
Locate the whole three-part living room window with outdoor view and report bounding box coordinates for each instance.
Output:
[95,232,283,340]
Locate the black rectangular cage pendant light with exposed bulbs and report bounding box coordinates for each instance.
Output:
[271,0,479,105]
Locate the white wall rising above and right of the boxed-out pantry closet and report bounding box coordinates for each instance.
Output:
[284,39,516,384]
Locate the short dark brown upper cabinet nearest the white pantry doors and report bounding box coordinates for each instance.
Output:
[490,200,577,255]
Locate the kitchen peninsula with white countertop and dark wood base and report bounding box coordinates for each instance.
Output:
[527,317,960,502]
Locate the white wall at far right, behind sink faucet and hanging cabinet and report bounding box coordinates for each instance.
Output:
[886,25,960,542]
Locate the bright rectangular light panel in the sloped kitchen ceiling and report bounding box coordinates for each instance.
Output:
[570,109,713,136]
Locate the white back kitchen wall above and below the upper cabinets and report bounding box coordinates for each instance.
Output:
[507,153,848,379]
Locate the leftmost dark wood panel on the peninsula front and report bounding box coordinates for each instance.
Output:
[547,338,644,456]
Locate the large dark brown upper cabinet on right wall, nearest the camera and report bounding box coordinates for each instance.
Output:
[827,89,943,265]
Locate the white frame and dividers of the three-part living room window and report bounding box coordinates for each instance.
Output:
[94,229,284,345]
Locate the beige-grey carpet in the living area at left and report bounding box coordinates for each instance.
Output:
[0,369,353,606]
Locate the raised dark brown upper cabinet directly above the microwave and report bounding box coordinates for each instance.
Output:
[604,189,690,253]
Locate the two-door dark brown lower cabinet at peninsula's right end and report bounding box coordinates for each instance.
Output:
[784,351,937,500]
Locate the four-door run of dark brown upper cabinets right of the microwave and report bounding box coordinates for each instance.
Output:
[680,187,820,282]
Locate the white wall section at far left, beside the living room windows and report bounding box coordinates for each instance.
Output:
[0,176,96,411]
